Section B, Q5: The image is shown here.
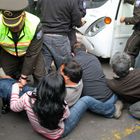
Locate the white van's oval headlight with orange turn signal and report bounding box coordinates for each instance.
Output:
[85,17,111,37]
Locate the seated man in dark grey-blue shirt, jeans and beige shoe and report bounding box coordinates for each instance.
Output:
[74,43,123,119]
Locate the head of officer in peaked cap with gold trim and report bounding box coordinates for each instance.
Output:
[0,0,28,32]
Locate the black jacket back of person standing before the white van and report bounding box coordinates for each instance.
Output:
[37,0,82,34]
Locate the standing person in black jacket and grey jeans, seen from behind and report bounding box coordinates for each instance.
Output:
[37,0,82,72]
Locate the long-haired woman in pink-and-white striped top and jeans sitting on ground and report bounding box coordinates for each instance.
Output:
[10,72,88,140]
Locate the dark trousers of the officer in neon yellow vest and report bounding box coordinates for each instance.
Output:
[0,48,45,86]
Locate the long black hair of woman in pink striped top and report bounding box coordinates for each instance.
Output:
[33,72,66,130]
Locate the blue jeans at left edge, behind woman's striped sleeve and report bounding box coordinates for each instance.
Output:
[0,78,33,102]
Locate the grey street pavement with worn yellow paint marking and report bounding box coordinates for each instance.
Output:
[0,59,140,140]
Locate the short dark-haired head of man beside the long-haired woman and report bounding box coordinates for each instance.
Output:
[60,59,82,84]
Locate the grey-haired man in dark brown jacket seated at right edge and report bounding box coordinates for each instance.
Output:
[108,52,140,103]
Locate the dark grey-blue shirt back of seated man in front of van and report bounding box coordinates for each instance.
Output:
[75,44,113,101]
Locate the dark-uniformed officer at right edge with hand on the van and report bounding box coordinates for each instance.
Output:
[120,0,140,67]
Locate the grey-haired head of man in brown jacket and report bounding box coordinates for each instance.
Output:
[110,52,131,77]
